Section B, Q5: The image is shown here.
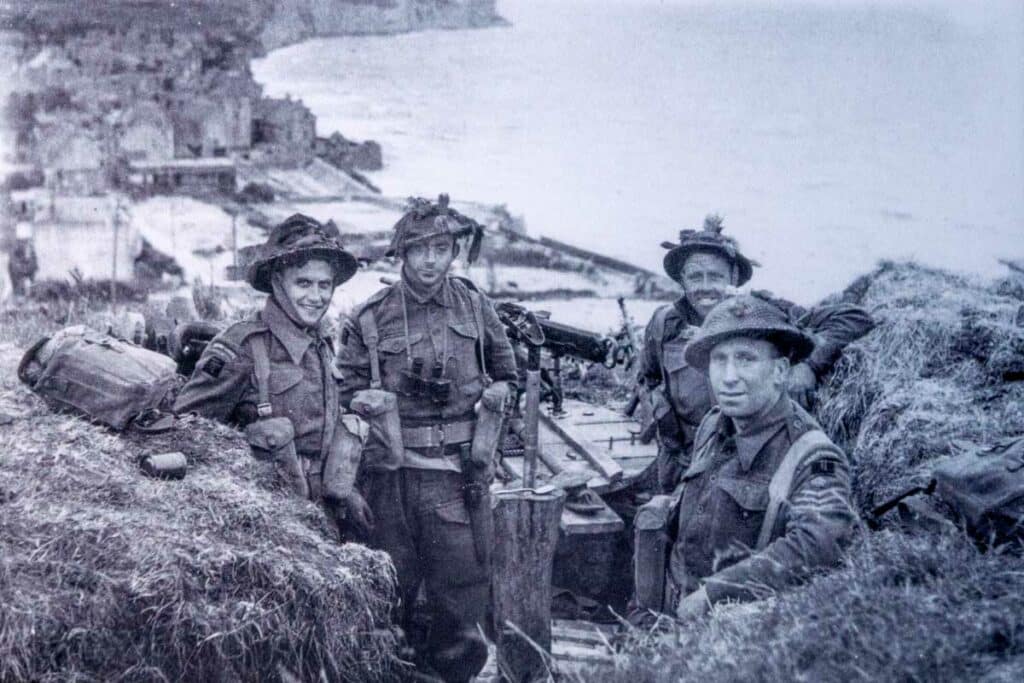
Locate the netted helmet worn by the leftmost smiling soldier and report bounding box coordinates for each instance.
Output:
[246,213,359,294]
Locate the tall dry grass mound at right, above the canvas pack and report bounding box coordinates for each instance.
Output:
[819,263,1024,509]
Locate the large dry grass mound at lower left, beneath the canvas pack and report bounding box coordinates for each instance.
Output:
[0,342,393,681]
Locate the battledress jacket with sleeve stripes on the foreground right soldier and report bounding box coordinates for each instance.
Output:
[666,395,856,609]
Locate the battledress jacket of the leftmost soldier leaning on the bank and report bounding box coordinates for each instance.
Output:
[174,299,357,500]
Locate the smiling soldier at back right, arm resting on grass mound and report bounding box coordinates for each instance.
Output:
[638,215,873,493]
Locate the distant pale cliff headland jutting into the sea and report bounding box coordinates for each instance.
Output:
[259,0,504,50]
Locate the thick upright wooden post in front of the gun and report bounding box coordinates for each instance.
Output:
[492,488,565,683]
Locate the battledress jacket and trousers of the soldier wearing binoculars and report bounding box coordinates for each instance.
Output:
[335,278,516,680]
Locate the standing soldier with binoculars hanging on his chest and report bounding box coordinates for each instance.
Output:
[335,195,516,681]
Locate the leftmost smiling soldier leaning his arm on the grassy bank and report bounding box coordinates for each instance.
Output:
[174,214,371,533]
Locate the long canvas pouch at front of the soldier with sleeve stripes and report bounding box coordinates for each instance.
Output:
[633,496,679,611]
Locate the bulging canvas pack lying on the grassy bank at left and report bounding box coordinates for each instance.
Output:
[17,326,182,431]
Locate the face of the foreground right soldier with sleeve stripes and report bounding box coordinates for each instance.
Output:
[708,337,790,421]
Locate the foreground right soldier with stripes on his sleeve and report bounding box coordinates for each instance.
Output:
[637,296,856,618]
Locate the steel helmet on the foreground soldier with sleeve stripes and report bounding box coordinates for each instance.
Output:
[683,294,814,370]
